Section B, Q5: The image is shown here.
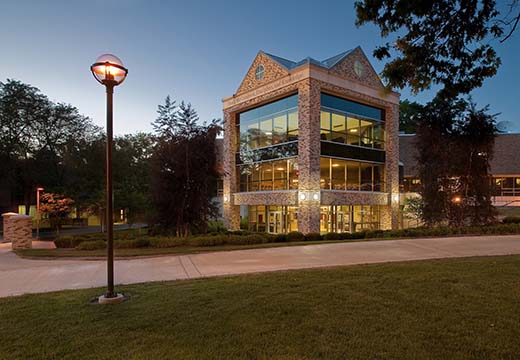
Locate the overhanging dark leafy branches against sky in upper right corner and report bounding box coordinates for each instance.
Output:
[355,0,520,99]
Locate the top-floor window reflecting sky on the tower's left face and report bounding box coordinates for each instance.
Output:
[238,95,298,152]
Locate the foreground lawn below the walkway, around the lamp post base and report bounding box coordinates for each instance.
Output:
[0,256,520,360]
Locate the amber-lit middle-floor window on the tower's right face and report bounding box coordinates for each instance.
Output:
[320,157,385,192]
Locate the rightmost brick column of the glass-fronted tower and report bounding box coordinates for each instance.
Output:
[381,104,399,230]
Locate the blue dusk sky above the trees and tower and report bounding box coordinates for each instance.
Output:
[0,0,520,134]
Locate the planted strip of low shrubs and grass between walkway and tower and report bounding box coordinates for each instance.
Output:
[14,222,520,257]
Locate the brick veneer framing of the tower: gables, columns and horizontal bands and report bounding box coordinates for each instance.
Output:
[224,58,399,233]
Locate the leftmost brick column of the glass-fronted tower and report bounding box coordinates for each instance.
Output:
[223,110,240,230]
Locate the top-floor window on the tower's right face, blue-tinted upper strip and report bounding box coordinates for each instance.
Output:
[320,94,385,150]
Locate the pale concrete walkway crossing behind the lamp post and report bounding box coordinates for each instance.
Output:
[0,235,520,297]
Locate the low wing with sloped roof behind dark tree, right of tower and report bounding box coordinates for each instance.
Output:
[399,134,520,207]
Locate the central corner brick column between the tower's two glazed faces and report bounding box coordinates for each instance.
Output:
[298,79,320,233]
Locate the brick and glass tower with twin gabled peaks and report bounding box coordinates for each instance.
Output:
[223,47,399,233]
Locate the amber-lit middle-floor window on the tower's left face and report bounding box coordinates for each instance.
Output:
[238,158,298,192]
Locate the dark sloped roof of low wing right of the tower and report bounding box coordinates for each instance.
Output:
[399,134,520,176]
